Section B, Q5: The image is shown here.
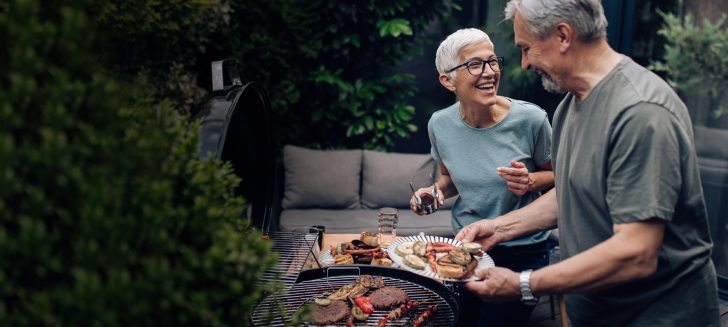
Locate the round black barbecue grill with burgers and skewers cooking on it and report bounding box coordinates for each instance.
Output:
[251,265,459,326]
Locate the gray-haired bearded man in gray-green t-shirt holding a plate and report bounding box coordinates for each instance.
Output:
[456,0,719,326]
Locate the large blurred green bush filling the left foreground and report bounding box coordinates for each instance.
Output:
[0,0,275,326]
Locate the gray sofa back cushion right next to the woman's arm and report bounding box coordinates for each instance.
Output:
[362,150,435,209]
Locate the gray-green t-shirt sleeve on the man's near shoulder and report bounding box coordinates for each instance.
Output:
[606,103,686,223]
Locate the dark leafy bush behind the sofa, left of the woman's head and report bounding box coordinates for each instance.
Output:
[231,0,457,149]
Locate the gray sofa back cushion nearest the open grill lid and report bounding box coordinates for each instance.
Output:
[281,145,362,209]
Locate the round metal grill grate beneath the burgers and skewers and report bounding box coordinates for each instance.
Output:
[252,275,457,326]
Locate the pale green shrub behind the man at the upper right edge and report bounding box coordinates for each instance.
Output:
[651,12,728,118]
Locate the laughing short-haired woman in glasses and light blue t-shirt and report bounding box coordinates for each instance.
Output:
[410,28,554,326]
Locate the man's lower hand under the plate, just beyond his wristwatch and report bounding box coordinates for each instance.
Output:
[465,267,521,302]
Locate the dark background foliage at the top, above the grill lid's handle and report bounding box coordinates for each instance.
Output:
[91,0,232,113]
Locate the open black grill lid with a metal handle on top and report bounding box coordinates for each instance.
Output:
[193,60,276,232]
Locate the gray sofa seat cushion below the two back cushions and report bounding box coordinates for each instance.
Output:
[280,209,453,237]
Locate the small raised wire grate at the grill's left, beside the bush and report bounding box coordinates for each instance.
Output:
[258,232,317,288]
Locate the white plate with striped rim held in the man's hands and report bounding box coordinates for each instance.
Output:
[386,235,495,282]
